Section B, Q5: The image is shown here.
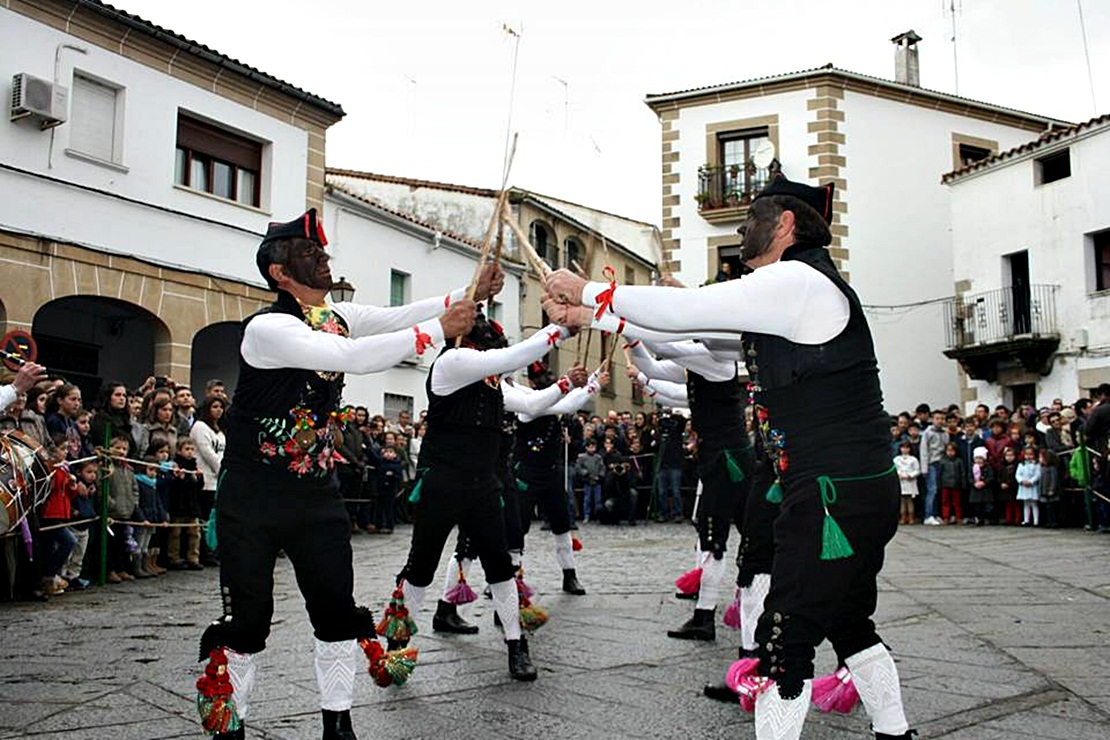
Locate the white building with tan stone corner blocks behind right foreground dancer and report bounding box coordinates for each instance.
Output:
[646,60,1063,412]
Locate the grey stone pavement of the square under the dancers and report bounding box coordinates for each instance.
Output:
[0,524,1110,740]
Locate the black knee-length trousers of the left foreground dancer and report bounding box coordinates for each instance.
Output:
[208,468,364,652]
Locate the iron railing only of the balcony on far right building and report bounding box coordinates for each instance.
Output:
[944,285,1059,349]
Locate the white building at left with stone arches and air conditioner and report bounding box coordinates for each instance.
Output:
[0,0,343,404]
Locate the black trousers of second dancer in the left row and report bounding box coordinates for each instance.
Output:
[400,468,515,587]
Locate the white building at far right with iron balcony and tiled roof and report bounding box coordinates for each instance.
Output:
[945,115,1110,408]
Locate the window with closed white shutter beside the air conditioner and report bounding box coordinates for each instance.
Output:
[69,73,123,164]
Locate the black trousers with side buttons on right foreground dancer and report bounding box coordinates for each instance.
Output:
[756,470,900,699]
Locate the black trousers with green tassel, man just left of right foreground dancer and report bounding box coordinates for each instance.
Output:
[694,446,755,560]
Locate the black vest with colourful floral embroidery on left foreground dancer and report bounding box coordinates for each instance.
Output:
[223,291,346,480]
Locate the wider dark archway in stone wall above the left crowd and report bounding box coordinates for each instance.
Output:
[31,295,170,405]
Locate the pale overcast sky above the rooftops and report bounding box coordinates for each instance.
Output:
[117,0,1110,223]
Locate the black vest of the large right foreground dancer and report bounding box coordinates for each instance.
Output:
[744,244,890,481]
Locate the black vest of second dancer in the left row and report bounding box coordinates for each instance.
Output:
[420,347,505,476]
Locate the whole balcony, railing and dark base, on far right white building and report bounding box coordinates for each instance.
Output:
[944,285,1060,382]
